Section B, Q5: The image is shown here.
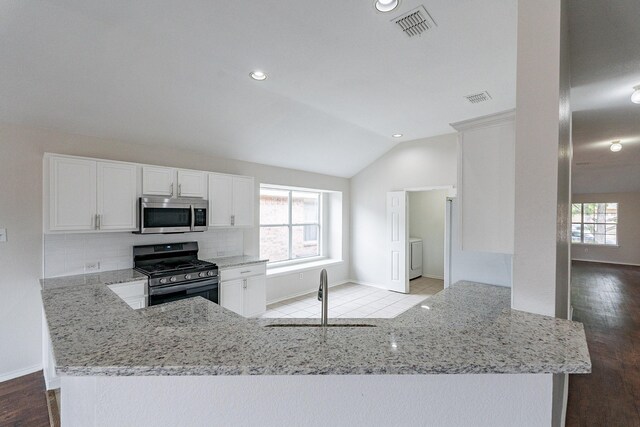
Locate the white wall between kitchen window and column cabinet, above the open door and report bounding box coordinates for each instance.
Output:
[351,134,457,285]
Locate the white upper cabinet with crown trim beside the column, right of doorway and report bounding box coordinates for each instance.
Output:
[452,111,515,254]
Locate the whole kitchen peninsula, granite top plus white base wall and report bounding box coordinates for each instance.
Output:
[42,282,591,426]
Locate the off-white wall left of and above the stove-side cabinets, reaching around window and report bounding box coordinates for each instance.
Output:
[0,125,350,380]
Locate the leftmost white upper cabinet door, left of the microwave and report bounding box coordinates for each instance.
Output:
[49,157,96,231]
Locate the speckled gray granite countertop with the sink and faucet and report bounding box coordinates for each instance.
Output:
[42,282,591,376]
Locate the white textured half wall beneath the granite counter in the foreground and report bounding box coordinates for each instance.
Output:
[61,374,552,427]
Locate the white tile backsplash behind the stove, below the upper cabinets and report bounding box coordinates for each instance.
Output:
[44,229,244,277]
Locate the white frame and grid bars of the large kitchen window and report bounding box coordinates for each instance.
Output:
[258,184,325,266]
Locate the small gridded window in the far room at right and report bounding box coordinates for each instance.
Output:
[571,203,618,245]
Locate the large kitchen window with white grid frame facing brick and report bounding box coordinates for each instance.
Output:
[260,186,322,263]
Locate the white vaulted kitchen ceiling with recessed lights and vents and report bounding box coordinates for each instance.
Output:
[0,0,516,177]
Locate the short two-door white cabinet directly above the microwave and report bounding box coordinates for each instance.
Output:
[142,166,207,198]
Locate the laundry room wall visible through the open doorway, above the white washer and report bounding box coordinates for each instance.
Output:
[407,190,447,279]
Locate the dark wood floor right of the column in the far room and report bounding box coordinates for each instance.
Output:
[567,262,640,427]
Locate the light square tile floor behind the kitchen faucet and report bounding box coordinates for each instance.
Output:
[262,277,444,318]
